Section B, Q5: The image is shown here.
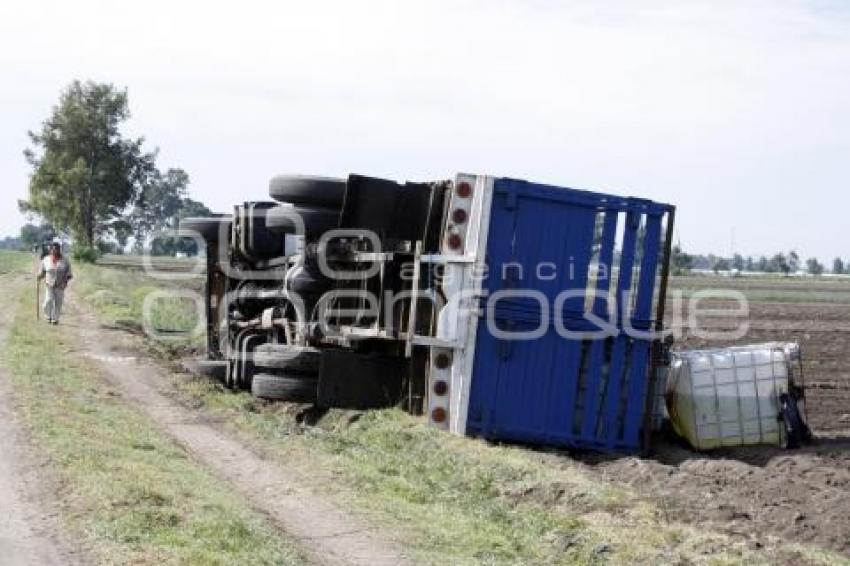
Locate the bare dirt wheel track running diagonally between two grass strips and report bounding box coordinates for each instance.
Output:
[63,292,409,566]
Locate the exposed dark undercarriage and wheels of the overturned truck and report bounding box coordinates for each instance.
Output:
[186,175,451,412]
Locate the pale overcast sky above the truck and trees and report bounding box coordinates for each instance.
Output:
[0,0,850,260]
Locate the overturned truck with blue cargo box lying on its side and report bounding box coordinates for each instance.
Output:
[181,174,804,451]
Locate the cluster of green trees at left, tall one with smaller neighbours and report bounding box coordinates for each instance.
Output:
[19,81,211,253]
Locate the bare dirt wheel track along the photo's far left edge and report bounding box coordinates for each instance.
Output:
[0,275,82,566]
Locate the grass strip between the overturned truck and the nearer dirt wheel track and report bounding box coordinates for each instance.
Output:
[73,260,841,564]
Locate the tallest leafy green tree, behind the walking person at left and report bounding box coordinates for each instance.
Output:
[21,81,155,248]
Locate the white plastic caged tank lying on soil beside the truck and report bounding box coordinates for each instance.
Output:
[666,342,799,450]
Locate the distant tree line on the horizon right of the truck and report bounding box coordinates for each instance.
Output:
[671,245,850,275]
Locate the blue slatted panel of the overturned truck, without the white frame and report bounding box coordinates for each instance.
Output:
[466,179,671,450]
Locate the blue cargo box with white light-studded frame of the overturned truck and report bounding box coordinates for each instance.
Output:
[420,175,674,451]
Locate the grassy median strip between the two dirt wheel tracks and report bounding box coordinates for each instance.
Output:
[2,280,304,565]
